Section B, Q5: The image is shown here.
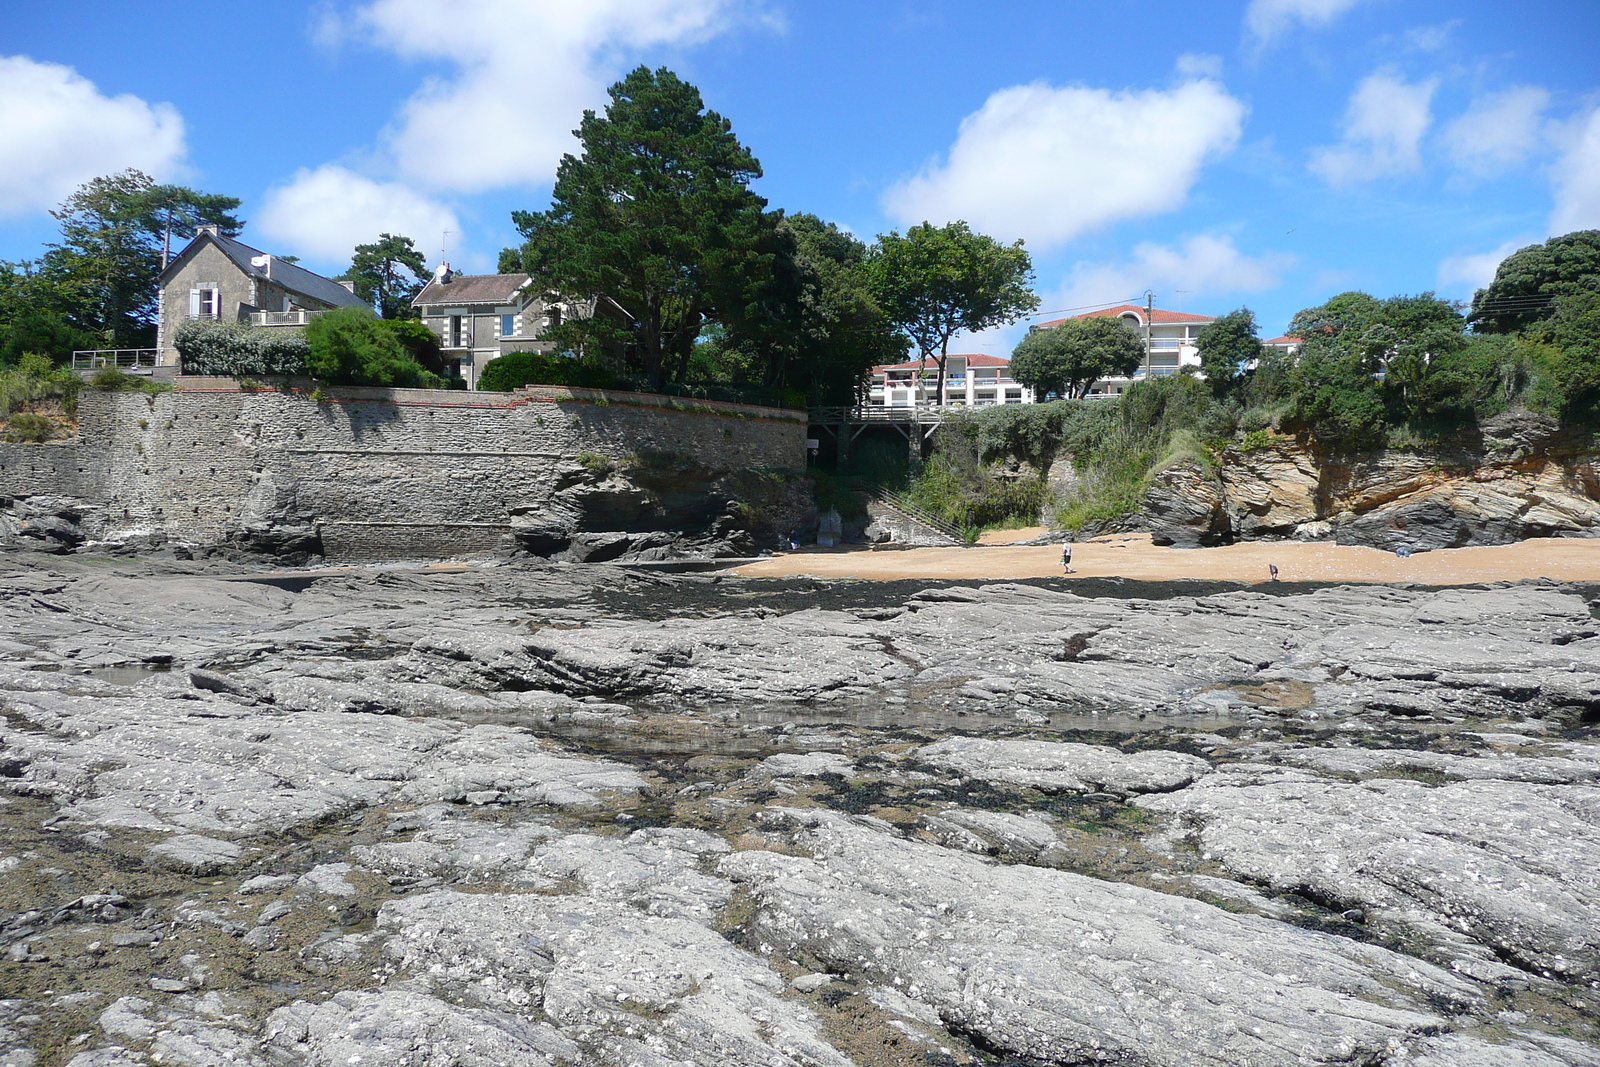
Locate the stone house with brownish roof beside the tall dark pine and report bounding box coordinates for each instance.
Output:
[411,262,573,389]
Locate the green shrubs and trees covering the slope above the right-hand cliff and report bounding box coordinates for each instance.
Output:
[896,230,1600,533]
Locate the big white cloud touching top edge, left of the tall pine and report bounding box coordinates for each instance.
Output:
[336,0,741,194]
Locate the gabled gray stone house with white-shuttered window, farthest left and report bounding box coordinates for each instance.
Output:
[155,226,368,365]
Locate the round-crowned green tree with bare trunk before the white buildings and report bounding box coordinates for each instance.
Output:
[870,222,1038,403]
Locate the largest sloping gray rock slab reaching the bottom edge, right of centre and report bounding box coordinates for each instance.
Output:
[720,809,1482,1067]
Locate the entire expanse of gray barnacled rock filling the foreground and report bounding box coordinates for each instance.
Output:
[0,553,1600,1067]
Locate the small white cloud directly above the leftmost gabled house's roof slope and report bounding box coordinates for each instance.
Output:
[256,163,461,267]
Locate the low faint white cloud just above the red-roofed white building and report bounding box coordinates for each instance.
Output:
[1045,234,1294,310]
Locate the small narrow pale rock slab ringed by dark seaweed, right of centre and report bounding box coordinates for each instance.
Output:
[915,737,1211,797]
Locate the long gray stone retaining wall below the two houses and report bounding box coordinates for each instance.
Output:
[0,378,806,558]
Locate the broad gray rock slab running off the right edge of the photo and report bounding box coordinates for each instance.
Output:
[1134,768,1600,981]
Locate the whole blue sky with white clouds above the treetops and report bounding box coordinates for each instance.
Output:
[0,0,1600,354]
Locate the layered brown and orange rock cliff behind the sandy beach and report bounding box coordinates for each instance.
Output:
[1123,413,1600,550]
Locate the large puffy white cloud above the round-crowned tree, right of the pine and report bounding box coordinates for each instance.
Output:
[883,78,1245,248]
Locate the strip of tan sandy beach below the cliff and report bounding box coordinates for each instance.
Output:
[733,530,1600,585]
